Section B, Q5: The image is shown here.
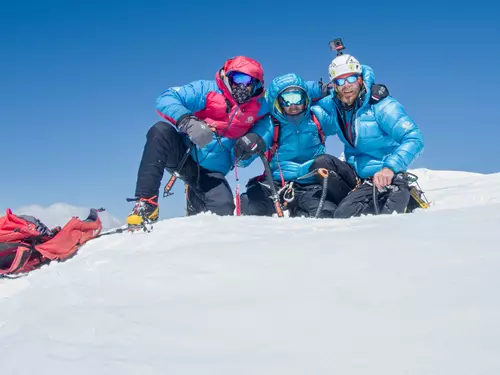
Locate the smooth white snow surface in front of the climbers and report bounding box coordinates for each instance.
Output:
[0,169,500,375]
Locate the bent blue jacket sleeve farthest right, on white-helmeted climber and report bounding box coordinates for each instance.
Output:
[373,97,424,173]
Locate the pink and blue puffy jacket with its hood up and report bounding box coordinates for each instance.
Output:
[156,56,269,175]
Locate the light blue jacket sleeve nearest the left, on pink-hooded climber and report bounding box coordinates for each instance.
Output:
[156,80,216,121]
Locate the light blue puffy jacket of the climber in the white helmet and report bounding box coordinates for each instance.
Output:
[311,66,424,178]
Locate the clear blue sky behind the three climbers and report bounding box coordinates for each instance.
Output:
[0,0,500,220]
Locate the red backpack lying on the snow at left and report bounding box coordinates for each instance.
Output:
[0,209,102,277]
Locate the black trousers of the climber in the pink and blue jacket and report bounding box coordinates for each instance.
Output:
[135,121,235,215]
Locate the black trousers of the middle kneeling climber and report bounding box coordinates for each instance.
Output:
[241,179,337,218]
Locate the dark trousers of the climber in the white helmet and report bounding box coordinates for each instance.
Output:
[334,174,410,219]
